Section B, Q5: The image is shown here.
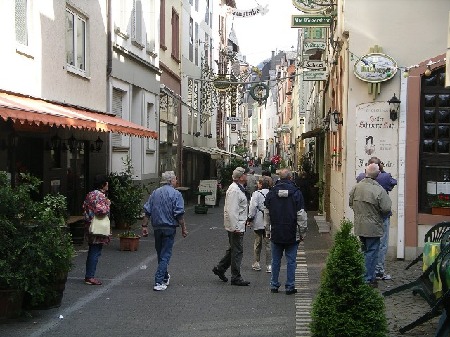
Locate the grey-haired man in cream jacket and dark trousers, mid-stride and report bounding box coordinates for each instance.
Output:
[213,167,250,286]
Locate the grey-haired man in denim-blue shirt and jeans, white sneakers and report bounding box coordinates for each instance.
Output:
[142,171,188,291]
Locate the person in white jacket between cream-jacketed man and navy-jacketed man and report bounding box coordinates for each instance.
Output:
[247,177,272,273]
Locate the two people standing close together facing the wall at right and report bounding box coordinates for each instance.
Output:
[349,157,397,287]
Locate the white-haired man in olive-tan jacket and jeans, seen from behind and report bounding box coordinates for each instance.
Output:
[349,163,392,287]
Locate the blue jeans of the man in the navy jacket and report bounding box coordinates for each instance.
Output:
[270,242,298,290]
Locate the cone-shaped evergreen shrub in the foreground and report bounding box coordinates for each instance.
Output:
[311,219,387,337]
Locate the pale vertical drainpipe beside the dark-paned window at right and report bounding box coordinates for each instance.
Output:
[397,69,408,259]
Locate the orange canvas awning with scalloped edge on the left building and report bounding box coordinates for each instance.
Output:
[0,92,158,139]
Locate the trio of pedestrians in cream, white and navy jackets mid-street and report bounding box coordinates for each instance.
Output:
[212,167,307,295]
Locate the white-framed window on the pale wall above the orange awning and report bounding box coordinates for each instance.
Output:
[66,8,86,75]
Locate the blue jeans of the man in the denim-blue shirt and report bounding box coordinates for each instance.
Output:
[153,227,177,284]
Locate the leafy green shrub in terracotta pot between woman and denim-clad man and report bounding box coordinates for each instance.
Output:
[108,157,145,228]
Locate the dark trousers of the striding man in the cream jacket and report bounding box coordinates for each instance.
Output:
[217,231,244,282]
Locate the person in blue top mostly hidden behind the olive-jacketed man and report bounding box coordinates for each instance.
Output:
[356,157,397,280]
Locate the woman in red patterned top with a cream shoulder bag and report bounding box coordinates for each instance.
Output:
[83,175,111,285]
